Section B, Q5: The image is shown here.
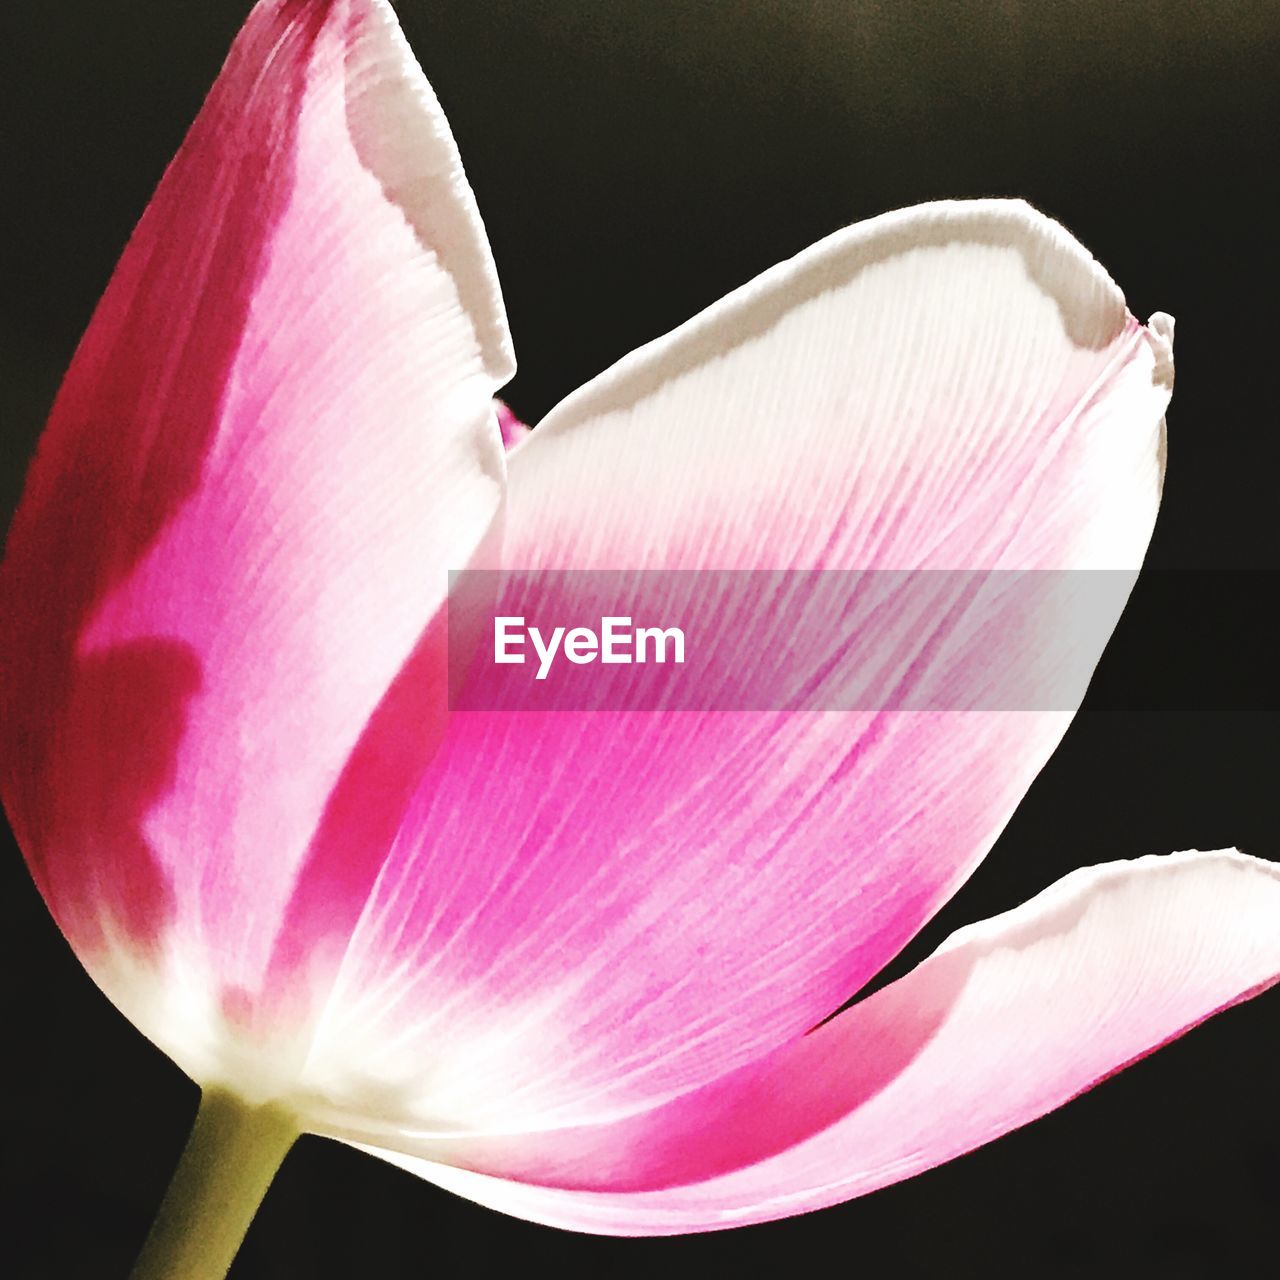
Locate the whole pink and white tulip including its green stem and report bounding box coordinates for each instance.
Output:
[0,0,1280,1277]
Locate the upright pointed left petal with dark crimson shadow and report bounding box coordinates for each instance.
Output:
[0,0,512,1078]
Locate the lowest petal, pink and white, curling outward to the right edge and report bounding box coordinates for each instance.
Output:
[348,852,1280,1235]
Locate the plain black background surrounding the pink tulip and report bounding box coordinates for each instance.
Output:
[0,0,1280,1280]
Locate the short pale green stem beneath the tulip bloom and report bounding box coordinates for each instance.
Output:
[131,1089,298,1280]
